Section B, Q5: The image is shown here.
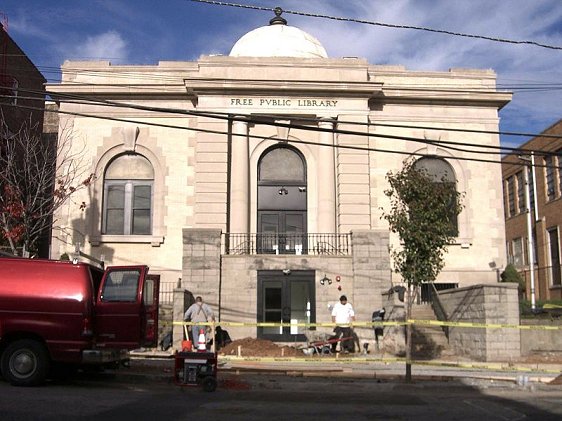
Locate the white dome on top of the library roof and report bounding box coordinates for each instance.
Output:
[230,25,328,58]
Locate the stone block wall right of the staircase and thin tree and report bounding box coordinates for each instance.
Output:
[439,283,521,361]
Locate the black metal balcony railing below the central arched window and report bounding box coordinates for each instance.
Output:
[223,232,351,256]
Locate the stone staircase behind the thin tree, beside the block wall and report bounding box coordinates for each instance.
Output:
[412,304,454,360]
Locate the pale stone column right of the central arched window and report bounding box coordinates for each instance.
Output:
[318,119,336,233]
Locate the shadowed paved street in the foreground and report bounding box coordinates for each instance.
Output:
[0,373,562,421]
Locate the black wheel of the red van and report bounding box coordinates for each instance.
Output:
[1,339,49,386]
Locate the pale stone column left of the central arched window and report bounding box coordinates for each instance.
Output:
[229,121,250,234]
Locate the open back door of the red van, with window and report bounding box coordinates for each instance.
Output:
[95,266,158,349]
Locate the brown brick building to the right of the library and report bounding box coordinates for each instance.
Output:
[502,120,562,300]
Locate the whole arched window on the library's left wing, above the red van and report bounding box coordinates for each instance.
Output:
[102,153,154,235]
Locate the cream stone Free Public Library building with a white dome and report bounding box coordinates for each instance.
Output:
[49,16,511,341]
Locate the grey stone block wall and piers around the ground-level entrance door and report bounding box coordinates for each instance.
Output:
[179,228,390,342]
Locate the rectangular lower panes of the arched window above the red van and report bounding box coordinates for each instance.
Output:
[103,180,152,235]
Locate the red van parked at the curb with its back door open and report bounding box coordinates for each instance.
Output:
[0,258,159,386]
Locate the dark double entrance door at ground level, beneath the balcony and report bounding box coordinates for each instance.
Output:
[257,270,316,342]
